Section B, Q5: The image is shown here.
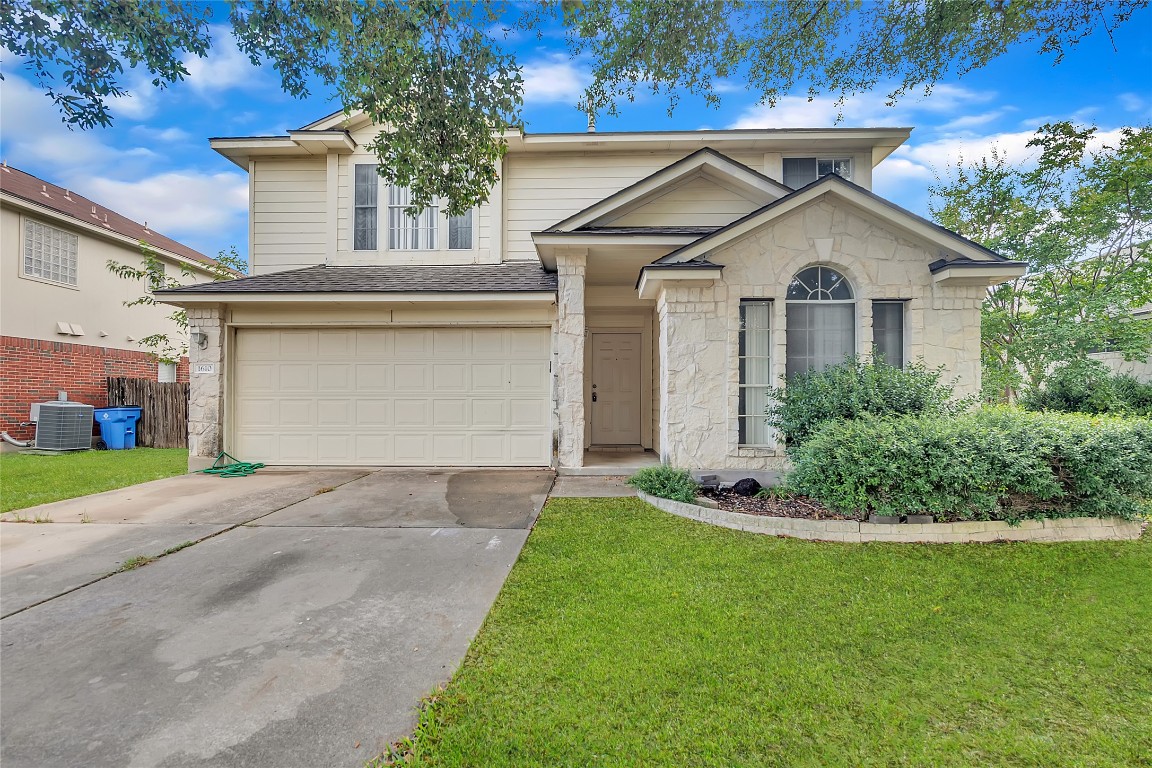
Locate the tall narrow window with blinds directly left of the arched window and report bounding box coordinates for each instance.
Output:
[740,299,772,447]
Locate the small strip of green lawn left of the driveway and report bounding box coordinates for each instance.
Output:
[0,448,188,512]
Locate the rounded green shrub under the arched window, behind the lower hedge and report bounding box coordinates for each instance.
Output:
[767,358,971,446]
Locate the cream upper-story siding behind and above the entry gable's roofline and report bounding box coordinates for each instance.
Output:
[503,152,764,261]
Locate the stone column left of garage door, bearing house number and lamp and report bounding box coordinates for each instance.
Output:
[188,306,225,471]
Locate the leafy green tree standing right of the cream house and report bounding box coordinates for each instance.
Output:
[930,122,1152,400]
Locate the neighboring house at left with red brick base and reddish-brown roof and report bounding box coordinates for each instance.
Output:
[0,164,222,439]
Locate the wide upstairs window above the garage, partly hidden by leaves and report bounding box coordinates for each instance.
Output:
[353,165,476,251]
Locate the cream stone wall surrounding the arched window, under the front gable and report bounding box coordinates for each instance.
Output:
[657,200,985,470]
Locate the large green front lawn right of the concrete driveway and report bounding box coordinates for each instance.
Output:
[389,499,1152,768]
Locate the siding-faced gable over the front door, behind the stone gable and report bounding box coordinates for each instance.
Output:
[547,147,791,233]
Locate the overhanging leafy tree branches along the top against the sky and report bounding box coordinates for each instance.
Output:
[0,0,1149,212]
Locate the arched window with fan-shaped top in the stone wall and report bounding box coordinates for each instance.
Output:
[786,266,856,378]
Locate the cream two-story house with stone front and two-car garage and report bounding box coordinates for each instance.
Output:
[157,115,1024,472]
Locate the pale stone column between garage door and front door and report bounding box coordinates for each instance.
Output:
[556,251,588,466]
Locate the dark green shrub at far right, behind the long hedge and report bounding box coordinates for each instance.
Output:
[1021,359,1152,416]
